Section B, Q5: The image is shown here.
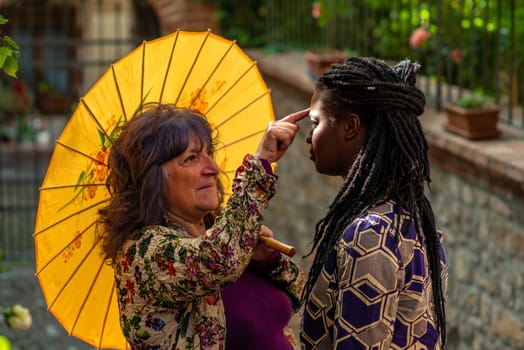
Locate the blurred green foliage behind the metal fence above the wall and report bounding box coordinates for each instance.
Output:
[216,0,524,100]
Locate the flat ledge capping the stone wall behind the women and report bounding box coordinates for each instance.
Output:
[247,50,524,201]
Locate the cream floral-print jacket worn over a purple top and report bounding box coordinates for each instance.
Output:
[115,155,303,350]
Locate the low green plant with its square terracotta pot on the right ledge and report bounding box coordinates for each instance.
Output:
[443,92,500,140]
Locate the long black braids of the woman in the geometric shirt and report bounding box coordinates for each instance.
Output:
[302,57,446,344]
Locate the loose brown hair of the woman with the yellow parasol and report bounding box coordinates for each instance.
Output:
[98,103,224,262]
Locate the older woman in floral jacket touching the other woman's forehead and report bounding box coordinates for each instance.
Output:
[100,105,307,349]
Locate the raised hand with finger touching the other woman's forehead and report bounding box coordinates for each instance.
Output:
[255,108,309,163]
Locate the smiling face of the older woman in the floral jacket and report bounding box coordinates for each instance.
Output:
[164,134,220,221]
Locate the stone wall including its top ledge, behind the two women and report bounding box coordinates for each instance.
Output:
[252,53,524,350]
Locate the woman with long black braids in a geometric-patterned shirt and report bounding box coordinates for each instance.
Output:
[300,58,447,350]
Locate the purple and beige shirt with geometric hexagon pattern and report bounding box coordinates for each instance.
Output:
[300,200,447,350]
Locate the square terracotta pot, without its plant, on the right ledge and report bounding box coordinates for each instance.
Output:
[444,104,500,140]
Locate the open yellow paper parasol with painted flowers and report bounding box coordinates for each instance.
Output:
[34,31,274,349]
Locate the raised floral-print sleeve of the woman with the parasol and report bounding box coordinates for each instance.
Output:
[116,156,275,302]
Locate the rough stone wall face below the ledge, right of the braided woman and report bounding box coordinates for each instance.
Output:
[430,166,524,350]
